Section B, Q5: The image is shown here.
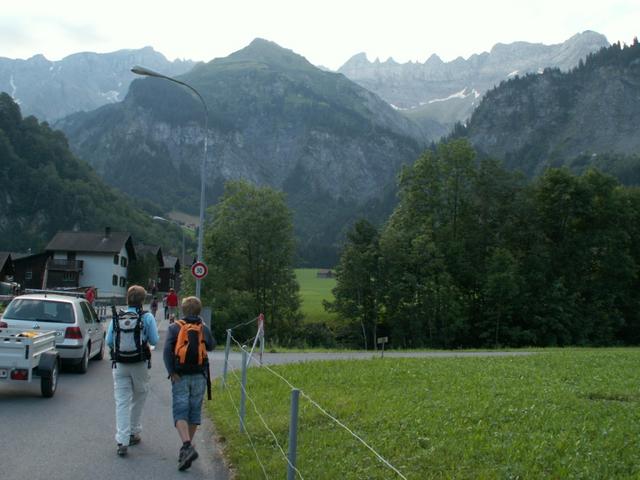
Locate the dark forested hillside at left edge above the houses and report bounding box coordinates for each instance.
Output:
[0,93,180,252]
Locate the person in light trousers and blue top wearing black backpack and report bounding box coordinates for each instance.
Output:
[106,285,158,456]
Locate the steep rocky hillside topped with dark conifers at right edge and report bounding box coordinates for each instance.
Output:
[455,39,640,180]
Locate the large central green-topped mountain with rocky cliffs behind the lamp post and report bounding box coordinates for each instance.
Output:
[56,39,428,266]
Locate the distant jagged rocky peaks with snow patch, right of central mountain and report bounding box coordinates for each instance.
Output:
[338,31,609,138]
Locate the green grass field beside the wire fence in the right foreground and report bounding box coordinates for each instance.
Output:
[207,349,640,480]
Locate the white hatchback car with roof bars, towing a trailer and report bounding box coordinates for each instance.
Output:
[0,293,105,373]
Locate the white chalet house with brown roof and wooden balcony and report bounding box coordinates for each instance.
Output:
[44,227,136,298]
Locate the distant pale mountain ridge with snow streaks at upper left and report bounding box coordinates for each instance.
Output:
[0,47,194,122]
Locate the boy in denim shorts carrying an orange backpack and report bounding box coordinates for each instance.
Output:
[163,297,215,470]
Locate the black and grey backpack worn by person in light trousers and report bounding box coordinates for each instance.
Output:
[111,306,151,368]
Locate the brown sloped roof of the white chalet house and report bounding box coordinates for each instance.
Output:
[45,232,135,259]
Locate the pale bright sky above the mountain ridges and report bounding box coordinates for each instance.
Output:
[0,0,640,70]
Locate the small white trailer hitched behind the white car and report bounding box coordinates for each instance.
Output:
[0,328,59,397]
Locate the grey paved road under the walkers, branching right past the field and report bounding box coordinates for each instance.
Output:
[0,308,525,480]
